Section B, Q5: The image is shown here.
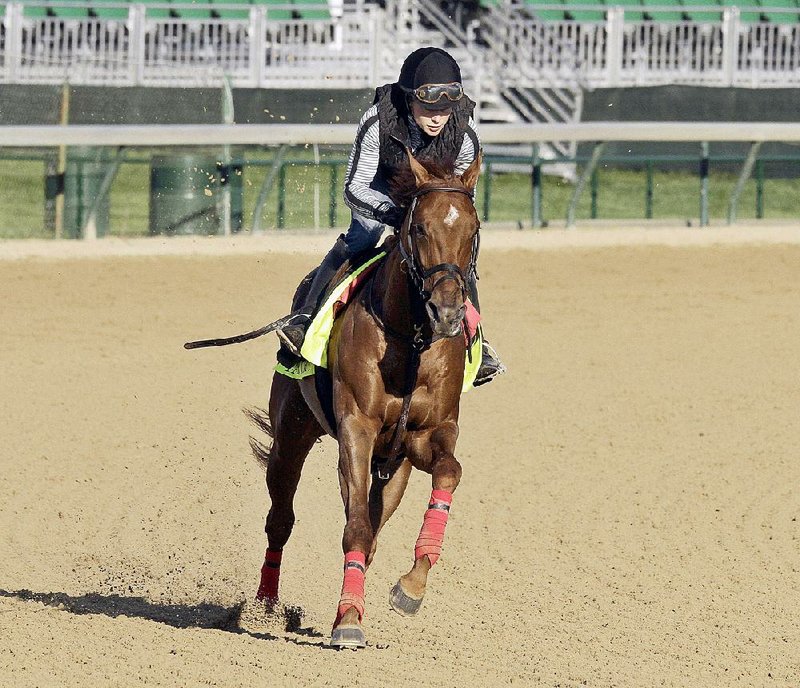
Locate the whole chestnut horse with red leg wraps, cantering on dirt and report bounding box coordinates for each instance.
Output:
[252,154,481,648]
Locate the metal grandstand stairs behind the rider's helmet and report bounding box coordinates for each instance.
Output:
[382,0,583,178]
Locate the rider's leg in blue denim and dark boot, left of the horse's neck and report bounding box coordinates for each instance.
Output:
[276,212,384,356]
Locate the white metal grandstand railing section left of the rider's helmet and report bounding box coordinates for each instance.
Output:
[0,2,381,89]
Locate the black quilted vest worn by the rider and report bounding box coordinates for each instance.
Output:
[373,84,478,199]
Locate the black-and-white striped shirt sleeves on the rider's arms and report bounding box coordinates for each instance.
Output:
[344,105,480,219]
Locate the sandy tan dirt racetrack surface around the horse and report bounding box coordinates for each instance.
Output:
[0,228,800,688]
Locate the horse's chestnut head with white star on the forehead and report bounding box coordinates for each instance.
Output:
[398,152,481,337]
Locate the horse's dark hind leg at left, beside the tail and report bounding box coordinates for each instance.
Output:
[252,373,323,603]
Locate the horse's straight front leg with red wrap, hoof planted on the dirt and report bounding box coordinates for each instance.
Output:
[331,412,379,649]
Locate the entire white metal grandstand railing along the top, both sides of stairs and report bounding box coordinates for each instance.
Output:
[0,0,800,89]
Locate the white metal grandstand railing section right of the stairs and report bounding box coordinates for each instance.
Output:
[487,4,800,88]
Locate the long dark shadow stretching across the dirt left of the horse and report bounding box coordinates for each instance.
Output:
[0,589,279,640]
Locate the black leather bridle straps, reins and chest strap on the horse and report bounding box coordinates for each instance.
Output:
[366,186,480,481]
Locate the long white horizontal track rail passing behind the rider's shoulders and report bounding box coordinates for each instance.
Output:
[0,122,800,147]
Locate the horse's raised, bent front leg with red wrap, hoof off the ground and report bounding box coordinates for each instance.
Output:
[390,422,461,616]
